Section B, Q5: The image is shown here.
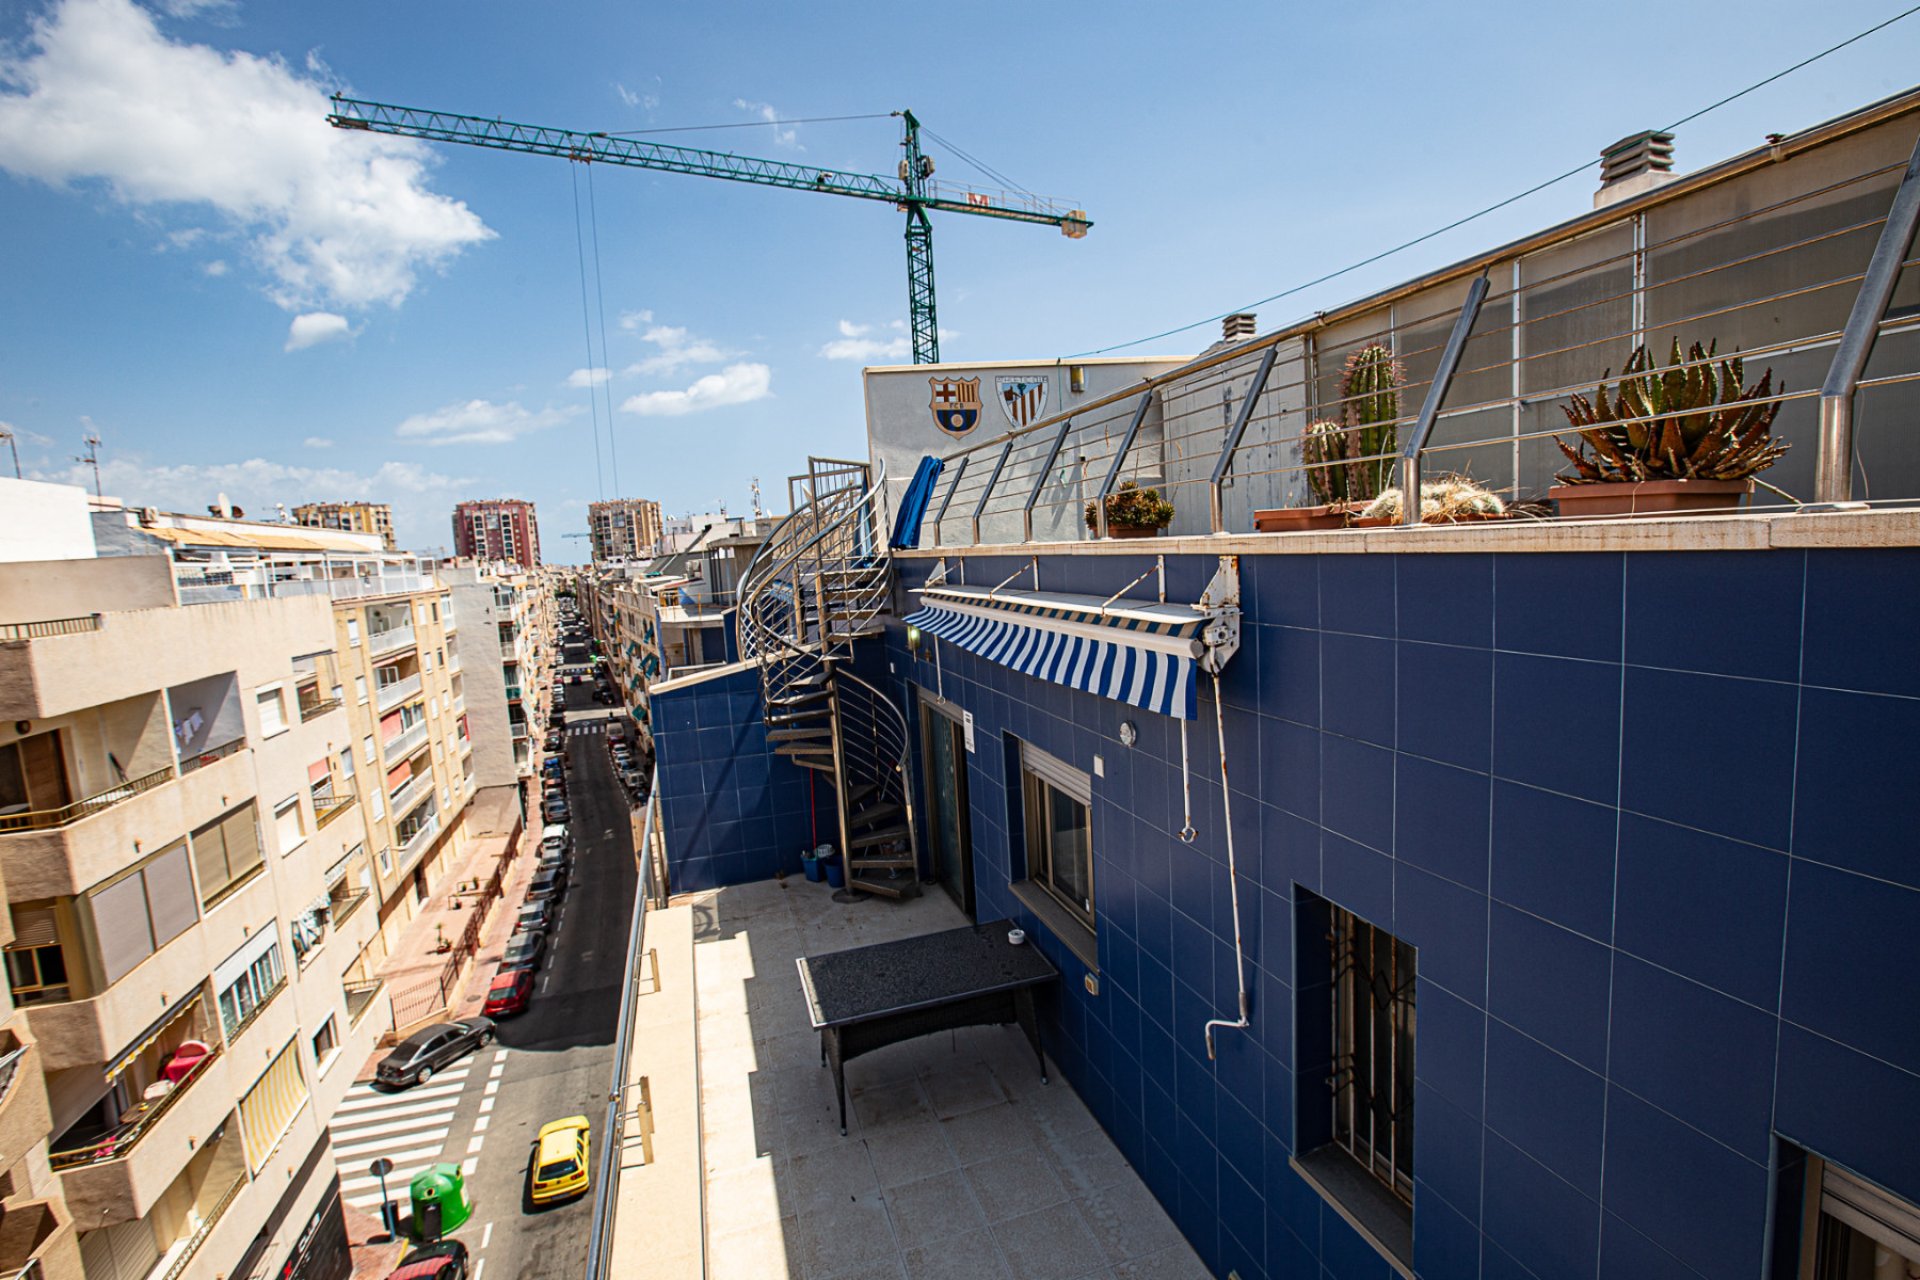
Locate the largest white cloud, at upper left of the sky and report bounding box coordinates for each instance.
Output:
[0,0,493,309]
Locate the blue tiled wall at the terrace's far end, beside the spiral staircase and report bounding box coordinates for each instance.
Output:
[653,670,817,892]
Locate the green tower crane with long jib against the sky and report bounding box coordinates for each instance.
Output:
[326,94,1092,365]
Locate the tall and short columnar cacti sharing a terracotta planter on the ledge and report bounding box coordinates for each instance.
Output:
[1254,342,1405,533]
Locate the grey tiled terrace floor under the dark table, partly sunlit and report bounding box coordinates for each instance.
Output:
[693,879,1208,1280]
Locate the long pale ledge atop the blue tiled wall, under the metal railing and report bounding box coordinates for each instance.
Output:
[893,507,1920,560]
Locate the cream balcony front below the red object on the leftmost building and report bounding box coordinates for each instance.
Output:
[50,1046,234,1226]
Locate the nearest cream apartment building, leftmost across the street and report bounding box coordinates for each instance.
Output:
[0,482,390,1280]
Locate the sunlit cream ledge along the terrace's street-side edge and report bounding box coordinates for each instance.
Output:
[611,904,707,1280]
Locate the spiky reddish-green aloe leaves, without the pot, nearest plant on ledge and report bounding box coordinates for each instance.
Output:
[1553,338,1788,484]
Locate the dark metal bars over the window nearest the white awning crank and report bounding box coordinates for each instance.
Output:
[1327,908,1413,1203]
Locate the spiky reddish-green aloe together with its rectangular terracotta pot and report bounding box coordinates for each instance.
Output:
[1548,338,1788,516]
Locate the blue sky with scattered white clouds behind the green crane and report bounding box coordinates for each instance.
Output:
[0,0,1920,560]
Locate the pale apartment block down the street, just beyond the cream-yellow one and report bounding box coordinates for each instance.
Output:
[440,564,553,789]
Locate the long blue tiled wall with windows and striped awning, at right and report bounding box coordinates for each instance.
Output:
[887,549,1920,1280]
